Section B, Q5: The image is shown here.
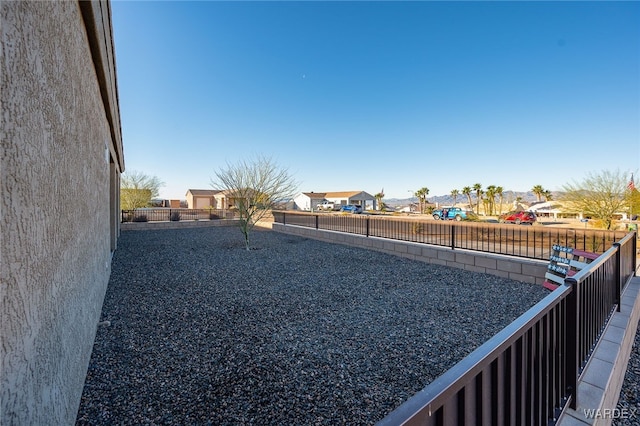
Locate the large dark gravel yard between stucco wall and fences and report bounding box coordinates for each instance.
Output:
[77,228,552,425]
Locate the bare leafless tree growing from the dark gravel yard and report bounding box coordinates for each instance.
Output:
[211,155,298,250]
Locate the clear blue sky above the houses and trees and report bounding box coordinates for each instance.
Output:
[112,0,640,199]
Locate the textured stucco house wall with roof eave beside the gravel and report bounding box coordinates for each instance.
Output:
[0,1,124,425]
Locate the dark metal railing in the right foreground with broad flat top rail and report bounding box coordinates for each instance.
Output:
[379,232,637,425]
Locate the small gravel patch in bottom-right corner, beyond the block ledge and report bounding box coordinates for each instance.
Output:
[613,324,640,426]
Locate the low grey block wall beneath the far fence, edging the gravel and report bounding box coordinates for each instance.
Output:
[272,223,548,284]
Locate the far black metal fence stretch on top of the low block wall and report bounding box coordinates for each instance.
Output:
[273,211,626,260]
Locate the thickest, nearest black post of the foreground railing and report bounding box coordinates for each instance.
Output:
[564,278,580,410]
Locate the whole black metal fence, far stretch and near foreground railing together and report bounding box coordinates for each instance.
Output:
[274,212,637,425]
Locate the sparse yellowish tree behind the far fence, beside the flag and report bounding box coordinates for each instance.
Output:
[561,170,630,229]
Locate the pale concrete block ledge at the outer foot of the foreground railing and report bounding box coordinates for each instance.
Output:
[557,277,640,426]
